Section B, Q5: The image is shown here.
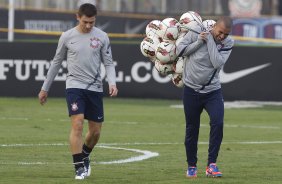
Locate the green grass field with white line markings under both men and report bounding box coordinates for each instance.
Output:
[0,98,282,184]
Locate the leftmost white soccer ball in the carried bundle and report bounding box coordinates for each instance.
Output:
[140,37,160,58]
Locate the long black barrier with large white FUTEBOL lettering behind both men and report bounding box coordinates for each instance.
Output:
[0,42,282,101]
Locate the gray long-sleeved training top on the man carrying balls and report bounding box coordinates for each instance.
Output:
[176,26,234,93]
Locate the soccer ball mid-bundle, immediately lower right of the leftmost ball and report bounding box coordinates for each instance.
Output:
[156,41,177,64]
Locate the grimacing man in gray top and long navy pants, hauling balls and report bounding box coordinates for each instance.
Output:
[177,17,234,178]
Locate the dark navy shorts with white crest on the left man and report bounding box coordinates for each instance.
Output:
[66,88,104,122]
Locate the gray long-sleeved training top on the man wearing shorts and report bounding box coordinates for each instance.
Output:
[42,27,116,92]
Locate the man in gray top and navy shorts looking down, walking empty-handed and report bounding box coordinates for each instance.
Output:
[38,3,118,179]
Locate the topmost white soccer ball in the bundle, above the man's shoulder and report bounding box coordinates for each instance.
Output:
[179,11,203,31]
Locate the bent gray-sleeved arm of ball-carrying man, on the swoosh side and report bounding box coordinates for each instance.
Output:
[207,34,234,69]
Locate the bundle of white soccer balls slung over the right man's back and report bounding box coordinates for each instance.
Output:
[140,11,215,87]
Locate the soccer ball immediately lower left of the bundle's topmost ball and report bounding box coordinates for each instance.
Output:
[157,18,180,41]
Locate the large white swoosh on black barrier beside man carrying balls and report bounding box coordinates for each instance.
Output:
[219,63,271,84]
